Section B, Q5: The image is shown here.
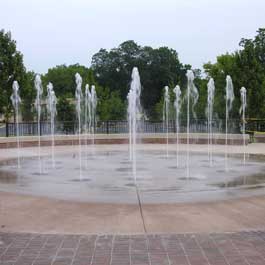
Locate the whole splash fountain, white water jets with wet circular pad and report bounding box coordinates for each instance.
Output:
[0,68,265,207]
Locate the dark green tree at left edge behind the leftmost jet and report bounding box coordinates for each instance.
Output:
[0,30,27,121]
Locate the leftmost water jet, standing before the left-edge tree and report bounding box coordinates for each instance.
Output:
[10,81,21,168]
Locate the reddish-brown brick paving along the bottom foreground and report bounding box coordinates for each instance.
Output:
[0,231,265,265]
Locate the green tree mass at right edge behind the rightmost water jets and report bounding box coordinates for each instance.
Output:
[204,29,265,118]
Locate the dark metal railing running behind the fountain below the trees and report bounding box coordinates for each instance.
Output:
[0,119,246,137]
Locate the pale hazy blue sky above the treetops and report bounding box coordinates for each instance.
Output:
[0,0,265,73]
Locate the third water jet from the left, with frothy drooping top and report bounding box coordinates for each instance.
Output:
[47,82,57,167]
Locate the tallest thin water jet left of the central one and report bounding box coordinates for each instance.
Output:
[75,73,83,180]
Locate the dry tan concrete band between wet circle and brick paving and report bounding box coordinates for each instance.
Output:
[0,192,265,233]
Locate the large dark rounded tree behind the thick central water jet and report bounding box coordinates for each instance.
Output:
[91,40,189,117]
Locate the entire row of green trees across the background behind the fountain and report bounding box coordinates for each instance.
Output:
[0,28,265,121]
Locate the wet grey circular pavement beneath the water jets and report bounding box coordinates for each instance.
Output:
[0,150,265,204]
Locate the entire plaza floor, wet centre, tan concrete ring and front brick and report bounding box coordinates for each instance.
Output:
[0,139,265,265]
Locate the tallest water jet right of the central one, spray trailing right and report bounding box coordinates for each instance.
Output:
[186,70,199,178]
